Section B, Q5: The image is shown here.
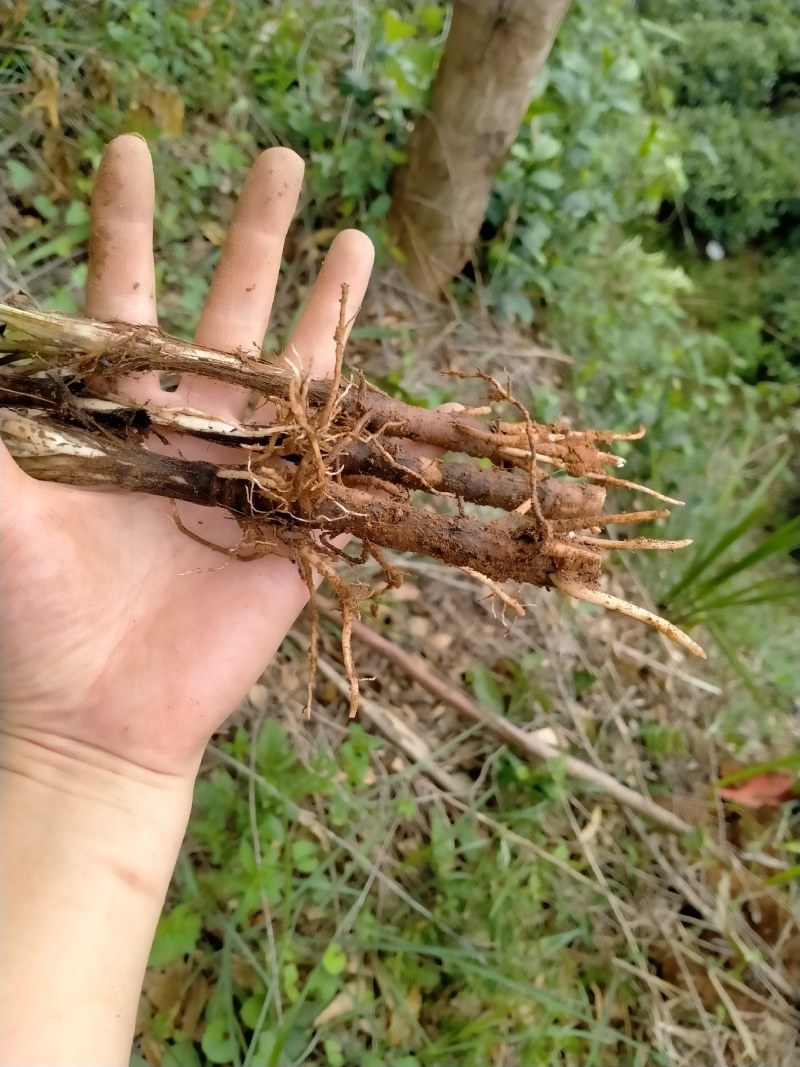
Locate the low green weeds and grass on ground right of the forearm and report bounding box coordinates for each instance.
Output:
[137,708,657,1065]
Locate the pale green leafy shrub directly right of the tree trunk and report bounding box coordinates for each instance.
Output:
[482,0,684,322]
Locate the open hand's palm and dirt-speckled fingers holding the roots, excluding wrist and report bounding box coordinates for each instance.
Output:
[0,134,372,775]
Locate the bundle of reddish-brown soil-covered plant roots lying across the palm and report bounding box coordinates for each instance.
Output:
[0,298,704,712]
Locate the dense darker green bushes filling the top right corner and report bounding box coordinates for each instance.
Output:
[639,0,800,403]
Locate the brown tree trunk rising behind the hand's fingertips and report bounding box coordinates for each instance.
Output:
[390,0,570,294]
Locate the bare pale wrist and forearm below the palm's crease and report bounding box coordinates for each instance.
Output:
[0,733,192,1067]
